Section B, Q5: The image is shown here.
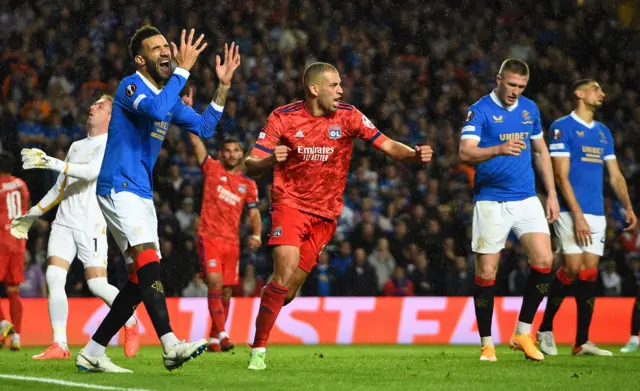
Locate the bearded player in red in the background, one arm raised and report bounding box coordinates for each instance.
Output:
[183,91,262,352]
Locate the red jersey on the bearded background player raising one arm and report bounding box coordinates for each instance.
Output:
[198,156,258,243]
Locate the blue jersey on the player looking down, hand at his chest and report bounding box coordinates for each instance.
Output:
[460,92,543,202]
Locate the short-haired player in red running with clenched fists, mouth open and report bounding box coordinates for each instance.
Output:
[245,62,432,370]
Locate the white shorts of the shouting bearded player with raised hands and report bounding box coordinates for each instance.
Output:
[98,190,161,264]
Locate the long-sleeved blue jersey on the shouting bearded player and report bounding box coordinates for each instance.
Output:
[97,68,223,198]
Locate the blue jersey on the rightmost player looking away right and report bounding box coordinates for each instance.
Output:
[549,112,616,216]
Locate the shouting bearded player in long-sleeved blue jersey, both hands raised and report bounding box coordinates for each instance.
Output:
[70,26,240,372]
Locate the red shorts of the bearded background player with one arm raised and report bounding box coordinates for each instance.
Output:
[198,236,240,286]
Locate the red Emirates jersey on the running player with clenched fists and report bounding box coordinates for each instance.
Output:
[251,101,387,219]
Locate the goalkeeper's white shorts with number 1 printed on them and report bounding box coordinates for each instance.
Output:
[47,222,108,269]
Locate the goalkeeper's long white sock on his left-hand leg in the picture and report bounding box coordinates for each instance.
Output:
[46,265,69,346]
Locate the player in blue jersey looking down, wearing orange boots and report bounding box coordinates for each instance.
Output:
[459,59,559,361]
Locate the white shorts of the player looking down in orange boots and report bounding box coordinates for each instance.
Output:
[471,197,549,254]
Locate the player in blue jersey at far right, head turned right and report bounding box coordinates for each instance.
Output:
[538,79,638,356]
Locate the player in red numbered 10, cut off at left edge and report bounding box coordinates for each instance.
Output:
[0,153,29,351]
